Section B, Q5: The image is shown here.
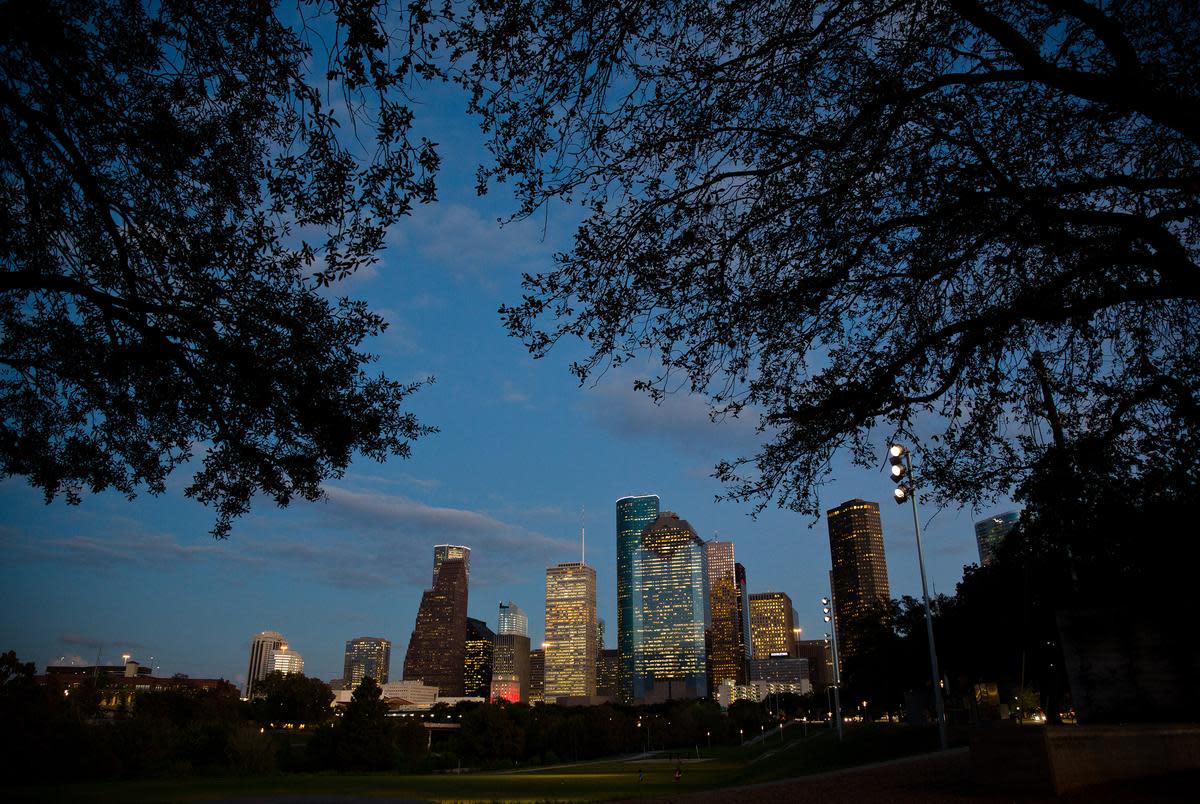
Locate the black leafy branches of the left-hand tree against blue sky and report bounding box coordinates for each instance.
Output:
[0,0,439,536]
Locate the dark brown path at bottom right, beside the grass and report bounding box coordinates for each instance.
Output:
[633,748,1200,804]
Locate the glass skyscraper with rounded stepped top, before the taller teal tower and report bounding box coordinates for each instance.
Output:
[632,511,709,703]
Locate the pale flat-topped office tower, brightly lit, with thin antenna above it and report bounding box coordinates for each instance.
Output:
[546,562,596,702]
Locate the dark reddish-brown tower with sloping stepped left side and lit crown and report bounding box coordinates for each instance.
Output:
[404,557,467,697]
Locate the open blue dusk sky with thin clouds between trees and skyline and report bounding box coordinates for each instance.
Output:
[0,77,1012,685]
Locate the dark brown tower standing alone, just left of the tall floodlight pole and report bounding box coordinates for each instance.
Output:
[826,499,892,666]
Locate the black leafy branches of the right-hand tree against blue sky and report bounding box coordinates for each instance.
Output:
[455,0,1200,515]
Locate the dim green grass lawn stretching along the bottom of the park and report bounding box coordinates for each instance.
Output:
[5,724,937,804]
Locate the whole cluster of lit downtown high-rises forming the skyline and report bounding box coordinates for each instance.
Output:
[247,494,1007,707]
